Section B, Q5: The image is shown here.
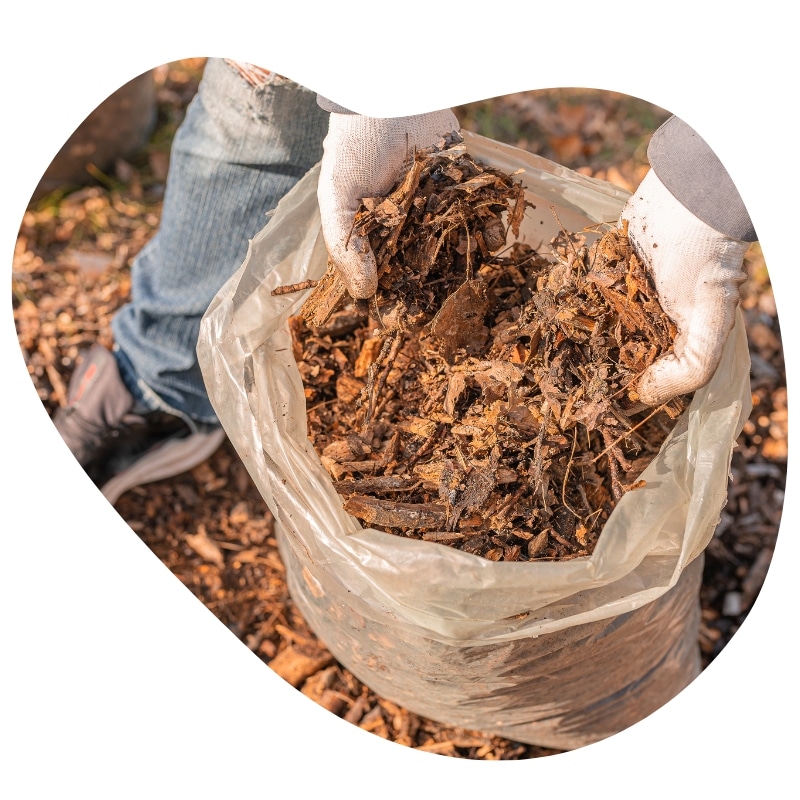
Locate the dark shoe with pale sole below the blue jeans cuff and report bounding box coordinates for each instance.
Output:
[53,345,225,504]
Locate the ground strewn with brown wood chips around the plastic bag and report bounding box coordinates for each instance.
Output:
[12,60,787,760]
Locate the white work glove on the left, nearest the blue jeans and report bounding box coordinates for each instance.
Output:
[317,109,460,299]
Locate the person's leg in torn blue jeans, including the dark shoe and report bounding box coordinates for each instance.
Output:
[54,59,328,503]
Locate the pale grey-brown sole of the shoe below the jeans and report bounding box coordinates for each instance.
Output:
[100,428,225,505]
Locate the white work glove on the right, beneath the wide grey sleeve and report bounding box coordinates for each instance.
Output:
[620,170,748,405]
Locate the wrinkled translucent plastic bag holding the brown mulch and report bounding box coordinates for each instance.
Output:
[198,133,750,749]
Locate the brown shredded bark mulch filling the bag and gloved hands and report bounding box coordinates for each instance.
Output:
[276,139,685,561]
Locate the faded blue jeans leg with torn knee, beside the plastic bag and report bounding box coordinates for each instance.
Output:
[112,59,328,425]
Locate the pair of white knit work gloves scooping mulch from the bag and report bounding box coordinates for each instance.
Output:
[318,110,748,405]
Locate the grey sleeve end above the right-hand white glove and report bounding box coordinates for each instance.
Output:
[647,116,758,242]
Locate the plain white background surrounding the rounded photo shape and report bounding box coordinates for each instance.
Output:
[0,0,798,798]
